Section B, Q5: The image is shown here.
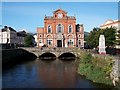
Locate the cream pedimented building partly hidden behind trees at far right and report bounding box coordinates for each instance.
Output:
[100,19,120,49]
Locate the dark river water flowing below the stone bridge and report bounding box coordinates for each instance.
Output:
[2,59,113,90]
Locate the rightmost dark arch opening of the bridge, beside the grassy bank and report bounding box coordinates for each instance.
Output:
[58,52,76,60]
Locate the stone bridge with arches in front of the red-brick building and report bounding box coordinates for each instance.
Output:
[21,47,80,58]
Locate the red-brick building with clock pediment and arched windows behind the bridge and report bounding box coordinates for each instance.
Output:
[37,9,84,47]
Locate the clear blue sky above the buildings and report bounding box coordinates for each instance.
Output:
[0,2,118,33]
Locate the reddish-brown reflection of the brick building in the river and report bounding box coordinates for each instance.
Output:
[37,62,77,88]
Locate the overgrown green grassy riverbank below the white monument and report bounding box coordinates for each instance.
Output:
[78,52,113,85]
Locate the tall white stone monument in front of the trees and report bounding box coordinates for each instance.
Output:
[99,35,106,54]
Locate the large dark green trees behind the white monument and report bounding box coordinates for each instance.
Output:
[87,27,116,48]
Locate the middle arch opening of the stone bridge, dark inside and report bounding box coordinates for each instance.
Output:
[39,52,57,60]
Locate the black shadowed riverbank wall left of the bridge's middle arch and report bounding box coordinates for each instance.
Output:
[1,49,36,65]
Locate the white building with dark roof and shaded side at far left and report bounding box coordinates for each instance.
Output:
[0,26,26,48]
